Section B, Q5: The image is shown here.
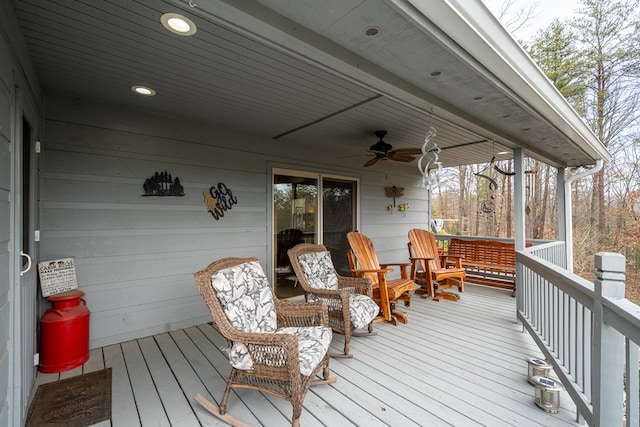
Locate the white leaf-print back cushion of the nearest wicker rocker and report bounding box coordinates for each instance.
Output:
[211,261,277,332]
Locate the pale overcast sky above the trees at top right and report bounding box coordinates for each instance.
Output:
[483,0,580,41]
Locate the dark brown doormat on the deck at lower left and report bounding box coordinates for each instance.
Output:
[25,368,111,427]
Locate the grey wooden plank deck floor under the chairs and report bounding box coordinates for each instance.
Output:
[37,285,579,427]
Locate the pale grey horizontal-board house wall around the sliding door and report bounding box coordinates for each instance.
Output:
[41,95,436,348]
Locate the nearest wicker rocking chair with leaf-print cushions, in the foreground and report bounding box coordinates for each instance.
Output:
[194,258,336,427]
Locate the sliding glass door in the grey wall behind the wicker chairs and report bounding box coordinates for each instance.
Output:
[273,169,357,298]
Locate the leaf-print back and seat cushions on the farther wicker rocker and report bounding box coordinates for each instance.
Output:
[298,251,380,329]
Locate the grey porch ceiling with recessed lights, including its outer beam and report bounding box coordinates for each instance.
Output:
[14,0,598,168]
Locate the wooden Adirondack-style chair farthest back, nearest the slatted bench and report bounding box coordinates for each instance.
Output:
[409,228,466,301]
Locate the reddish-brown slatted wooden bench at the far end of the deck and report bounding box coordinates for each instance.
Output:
[447,237,531,295]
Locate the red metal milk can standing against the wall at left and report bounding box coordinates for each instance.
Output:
[40,290,90,373]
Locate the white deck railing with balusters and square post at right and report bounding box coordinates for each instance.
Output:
[516,242,640,427]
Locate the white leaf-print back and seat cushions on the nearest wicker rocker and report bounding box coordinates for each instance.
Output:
[211,261,332,376]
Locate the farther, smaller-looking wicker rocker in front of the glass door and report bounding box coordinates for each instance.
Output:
[289,243,380,357]
